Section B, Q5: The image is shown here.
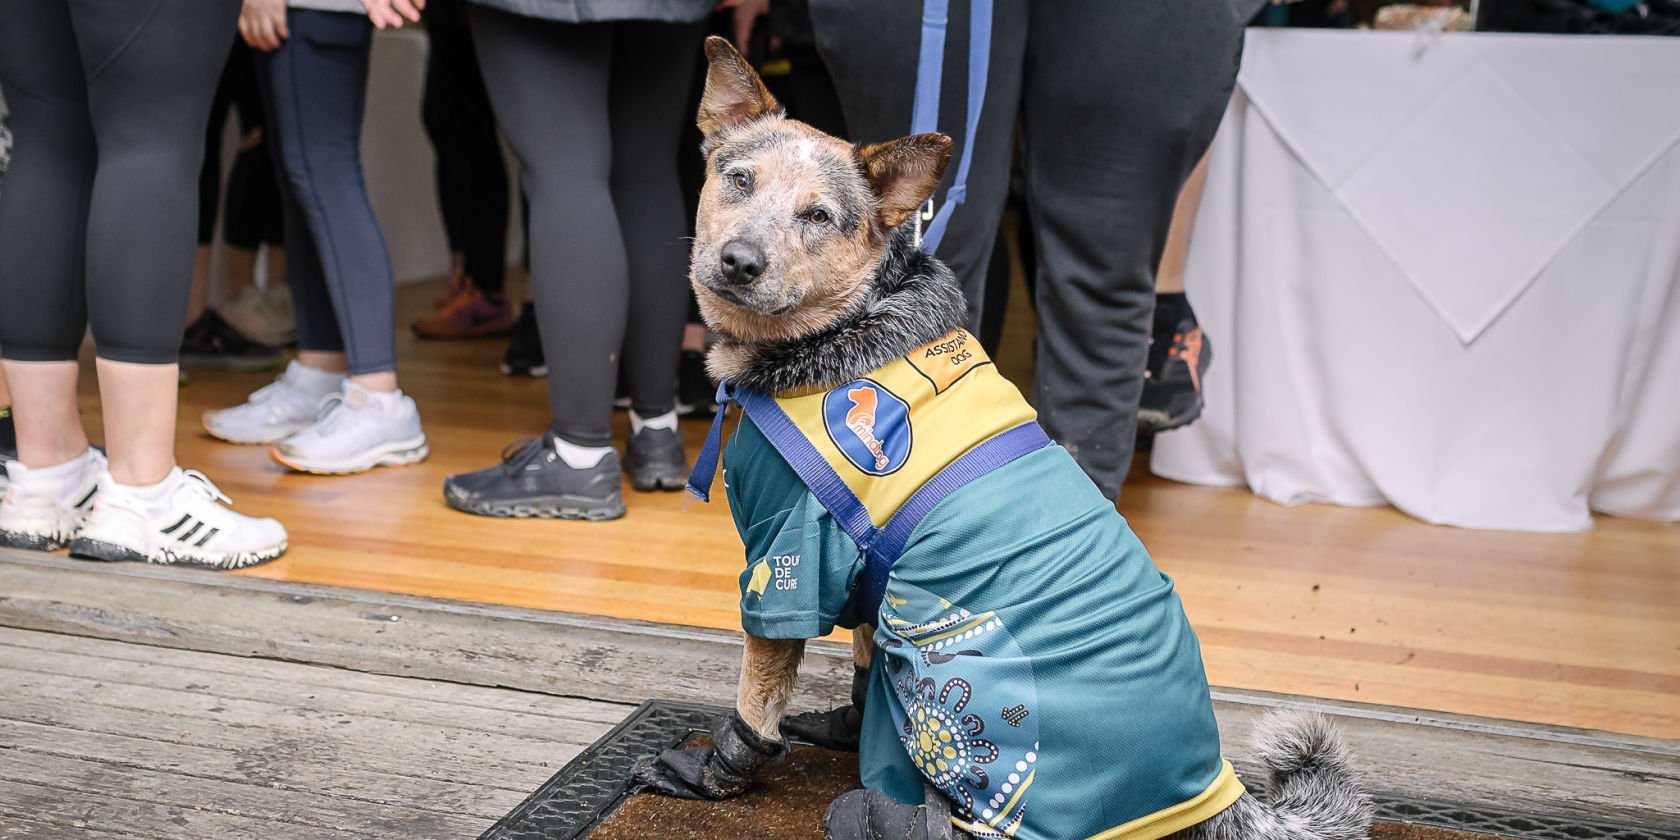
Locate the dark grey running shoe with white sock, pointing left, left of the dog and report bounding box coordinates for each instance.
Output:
[444,432,625,521]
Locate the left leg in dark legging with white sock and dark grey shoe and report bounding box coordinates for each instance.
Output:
[444,5,630,519]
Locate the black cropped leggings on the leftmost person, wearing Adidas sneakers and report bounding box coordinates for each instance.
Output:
[0,0,240,365]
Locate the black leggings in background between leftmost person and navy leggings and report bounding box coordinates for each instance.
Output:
[198,39,282,250]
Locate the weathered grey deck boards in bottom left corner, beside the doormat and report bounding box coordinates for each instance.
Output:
[0,628,632,840]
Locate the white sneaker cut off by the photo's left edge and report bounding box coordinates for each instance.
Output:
[0,449,106,551]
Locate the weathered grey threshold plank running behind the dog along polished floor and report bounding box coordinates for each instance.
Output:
[0,558,1680,825]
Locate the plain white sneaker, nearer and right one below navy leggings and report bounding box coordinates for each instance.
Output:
[270,381,430,475]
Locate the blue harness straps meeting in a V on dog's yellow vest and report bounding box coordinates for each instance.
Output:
[689,385,1050,617]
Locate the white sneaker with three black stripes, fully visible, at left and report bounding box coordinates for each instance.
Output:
[71,467,286,570]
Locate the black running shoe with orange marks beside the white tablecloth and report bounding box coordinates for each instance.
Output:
[1137,296,1213,433]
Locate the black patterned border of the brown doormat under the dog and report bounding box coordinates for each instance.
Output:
[479,701,1680,840]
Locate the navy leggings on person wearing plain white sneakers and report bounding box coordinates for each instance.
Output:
[257,8,396,376]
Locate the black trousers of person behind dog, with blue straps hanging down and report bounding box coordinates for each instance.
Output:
[811,0,1248,499]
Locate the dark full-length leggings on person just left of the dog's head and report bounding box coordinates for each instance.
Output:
[469,5,701,445]
